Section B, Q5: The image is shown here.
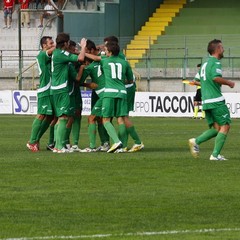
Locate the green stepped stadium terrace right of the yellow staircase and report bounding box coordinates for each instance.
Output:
[135,0,240,68]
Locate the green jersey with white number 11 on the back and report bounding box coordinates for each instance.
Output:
[101,56,133,99]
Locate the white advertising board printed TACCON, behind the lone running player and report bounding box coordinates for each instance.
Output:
[130,92,240,118]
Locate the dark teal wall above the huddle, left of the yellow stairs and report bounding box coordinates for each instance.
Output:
[63,0,163,47]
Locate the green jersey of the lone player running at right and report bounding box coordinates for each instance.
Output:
[200,56,225,110]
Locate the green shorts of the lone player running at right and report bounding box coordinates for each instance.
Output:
[205,105,231,127]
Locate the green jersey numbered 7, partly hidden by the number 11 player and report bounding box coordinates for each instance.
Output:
[80,62,105,95]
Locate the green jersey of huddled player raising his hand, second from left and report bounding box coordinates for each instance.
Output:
[51,48,78,94]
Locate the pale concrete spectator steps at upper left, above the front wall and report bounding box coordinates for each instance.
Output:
[0,0,109,69]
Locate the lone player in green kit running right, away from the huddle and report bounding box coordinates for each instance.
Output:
[189,39,235,160]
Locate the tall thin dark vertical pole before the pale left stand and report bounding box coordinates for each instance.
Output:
[18,9,22,90]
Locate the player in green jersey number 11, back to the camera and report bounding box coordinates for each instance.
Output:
[100,42,133,153]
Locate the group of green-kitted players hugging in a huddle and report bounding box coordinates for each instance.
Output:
[27,33,144,153]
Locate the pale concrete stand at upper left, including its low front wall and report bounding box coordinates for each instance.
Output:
[0,0,111,89]
